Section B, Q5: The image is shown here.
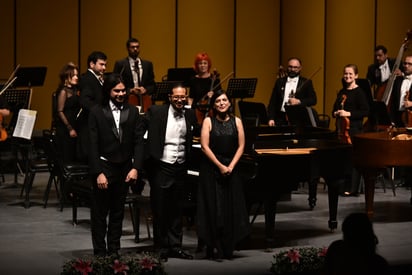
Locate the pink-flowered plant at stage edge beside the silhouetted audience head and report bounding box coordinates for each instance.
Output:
[270,247,327,274]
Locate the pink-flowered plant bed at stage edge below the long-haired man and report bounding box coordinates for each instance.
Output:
[60,252,166,275]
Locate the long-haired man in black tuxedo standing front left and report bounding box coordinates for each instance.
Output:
[89,74,144,256]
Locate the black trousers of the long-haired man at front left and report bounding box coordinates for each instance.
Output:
[90,162,131,256]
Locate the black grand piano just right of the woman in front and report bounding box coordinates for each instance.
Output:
[240,126,353,247]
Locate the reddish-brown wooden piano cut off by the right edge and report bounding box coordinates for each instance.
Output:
[352,128,412,218]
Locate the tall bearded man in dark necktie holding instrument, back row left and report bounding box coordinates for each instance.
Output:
[113,38,156,113]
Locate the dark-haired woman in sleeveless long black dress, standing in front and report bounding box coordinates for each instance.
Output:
[197,90,250,259]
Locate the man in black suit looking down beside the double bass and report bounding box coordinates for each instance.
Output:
[366,45,395,99]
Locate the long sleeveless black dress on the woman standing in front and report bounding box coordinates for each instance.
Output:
[197,117,250,258]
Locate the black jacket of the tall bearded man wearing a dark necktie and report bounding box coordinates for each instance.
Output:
[113,57,156,95]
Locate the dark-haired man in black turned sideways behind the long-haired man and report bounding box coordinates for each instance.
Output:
[76,51,107,162]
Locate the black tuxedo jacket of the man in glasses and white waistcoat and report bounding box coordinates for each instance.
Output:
[146,104,200,162]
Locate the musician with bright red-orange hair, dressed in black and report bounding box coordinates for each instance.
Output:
[188,52,221,123]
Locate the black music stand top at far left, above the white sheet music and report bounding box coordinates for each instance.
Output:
[14,67,47,87]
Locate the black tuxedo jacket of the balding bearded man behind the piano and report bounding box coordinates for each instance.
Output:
[268,76,317,122]
